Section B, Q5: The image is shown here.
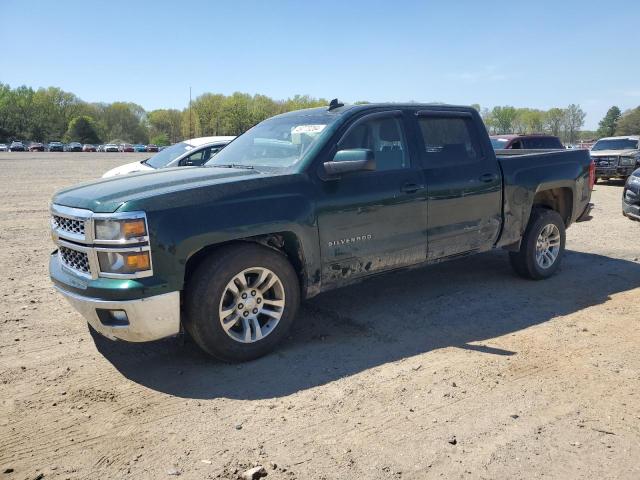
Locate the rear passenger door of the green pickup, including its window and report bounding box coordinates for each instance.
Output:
[417,110,502,260]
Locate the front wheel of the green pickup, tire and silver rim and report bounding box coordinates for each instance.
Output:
[184,244,300,362]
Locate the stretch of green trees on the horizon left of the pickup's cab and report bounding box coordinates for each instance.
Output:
[0,83,329,145]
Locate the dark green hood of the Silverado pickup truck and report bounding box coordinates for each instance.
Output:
[52,167,264,213]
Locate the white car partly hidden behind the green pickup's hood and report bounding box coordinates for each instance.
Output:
[102,137,236,178]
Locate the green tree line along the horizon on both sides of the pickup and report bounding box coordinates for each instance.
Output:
[0,83,640,145]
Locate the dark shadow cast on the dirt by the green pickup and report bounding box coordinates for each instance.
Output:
[93,251,640,399]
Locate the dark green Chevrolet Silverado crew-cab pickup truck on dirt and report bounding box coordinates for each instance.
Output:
[49,100,595,361]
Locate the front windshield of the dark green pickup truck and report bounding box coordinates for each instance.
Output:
[206,110,339,168]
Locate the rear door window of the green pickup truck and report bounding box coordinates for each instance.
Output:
[418,116,480,167]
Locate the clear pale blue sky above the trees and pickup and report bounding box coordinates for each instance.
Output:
[0,0,640,129]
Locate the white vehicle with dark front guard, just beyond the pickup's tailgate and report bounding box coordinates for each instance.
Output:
[591,135,640,182]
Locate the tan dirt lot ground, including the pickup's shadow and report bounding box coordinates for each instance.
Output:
[0,153,640,479]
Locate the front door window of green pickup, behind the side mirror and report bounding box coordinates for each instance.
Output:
[340,117,409,170]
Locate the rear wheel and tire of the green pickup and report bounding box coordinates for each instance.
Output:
[509,207,566,280]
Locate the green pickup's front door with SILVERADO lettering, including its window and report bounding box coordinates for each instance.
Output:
[318,115,427,286]
